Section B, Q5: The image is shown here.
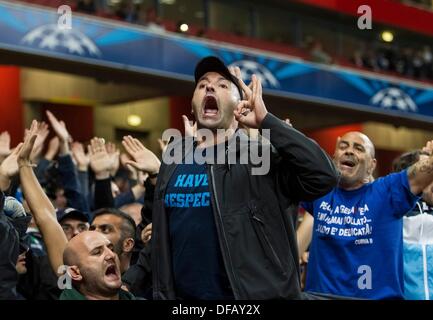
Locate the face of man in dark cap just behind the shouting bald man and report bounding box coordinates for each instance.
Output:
[56,208,89,241]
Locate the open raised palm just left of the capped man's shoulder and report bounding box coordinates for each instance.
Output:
[122,136,161,175]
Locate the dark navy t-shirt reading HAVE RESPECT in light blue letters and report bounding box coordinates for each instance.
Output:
[165,164,233,300]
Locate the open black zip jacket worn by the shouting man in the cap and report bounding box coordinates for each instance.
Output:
[152,114,337,299]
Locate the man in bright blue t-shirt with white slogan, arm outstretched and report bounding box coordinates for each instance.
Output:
[298,132,433,299]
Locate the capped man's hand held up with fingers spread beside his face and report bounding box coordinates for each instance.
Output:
[234,74,268,129]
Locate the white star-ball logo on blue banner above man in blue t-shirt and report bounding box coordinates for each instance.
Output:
[371,88,418,112]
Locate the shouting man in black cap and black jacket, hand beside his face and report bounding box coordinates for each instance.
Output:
[145,57,337,299]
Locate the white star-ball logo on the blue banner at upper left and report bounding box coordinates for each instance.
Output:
[21,24,101,57]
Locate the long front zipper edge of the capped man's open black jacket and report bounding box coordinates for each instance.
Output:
[209,164,240,299]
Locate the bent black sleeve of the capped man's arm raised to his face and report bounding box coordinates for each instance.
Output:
[261,113,338,201]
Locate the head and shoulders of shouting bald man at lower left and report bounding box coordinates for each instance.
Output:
[60,231,135,300]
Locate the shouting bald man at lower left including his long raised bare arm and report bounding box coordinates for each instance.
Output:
[17,120,134,300]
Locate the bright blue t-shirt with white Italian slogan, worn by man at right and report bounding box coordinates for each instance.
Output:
[301,171,419,299]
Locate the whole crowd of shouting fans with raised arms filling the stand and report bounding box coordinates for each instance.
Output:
[0,57,433,300]
